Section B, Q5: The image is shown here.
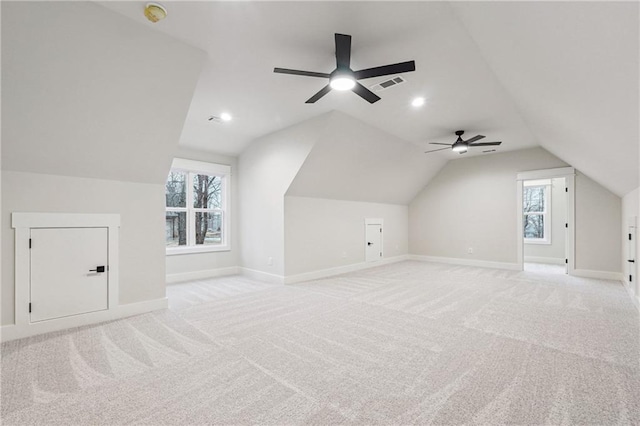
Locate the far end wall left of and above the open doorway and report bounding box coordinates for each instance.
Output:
[409,148,566,263]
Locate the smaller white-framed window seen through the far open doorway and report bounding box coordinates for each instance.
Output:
[522,179,551,244]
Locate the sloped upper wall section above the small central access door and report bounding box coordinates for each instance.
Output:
[287,111,446,204]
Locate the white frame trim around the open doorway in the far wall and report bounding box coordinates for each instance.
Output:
[516,167,576,275]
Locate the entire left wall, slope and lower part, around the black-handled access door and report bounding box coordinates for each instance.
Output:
[0,2,203,325]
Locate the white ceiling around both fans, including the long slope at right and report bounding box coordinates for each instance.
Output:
[100,1,638,195]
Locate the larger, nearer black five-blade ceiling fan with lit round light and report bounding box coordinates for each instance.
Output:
[273,34,416,104]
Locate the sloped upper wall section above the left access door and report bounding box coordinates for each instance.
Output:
[2,2,204,183]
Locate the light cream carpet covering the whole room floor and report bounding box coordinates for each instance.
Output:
[2,261,640,425]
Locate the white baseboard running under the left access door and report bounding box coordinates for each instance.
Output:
[0,297,167,342]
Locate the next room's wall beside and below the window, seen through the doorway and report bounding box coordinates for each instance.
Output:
[524,178,567,264]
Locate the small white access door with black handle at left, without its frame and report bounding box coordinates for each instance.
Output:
[29,228,109,322]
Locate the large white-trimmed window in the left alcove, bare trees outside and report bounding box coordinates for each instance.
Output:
[165,158,230,254]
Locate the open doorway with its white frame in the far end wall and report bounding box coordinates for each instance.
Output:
[516,167,575,274]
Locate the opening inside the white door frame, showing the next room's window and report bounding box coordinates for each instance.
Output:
[522,177,568,274]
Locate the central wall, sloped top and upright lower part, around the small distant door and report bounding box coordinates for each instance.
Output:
[284,111,445,277]
